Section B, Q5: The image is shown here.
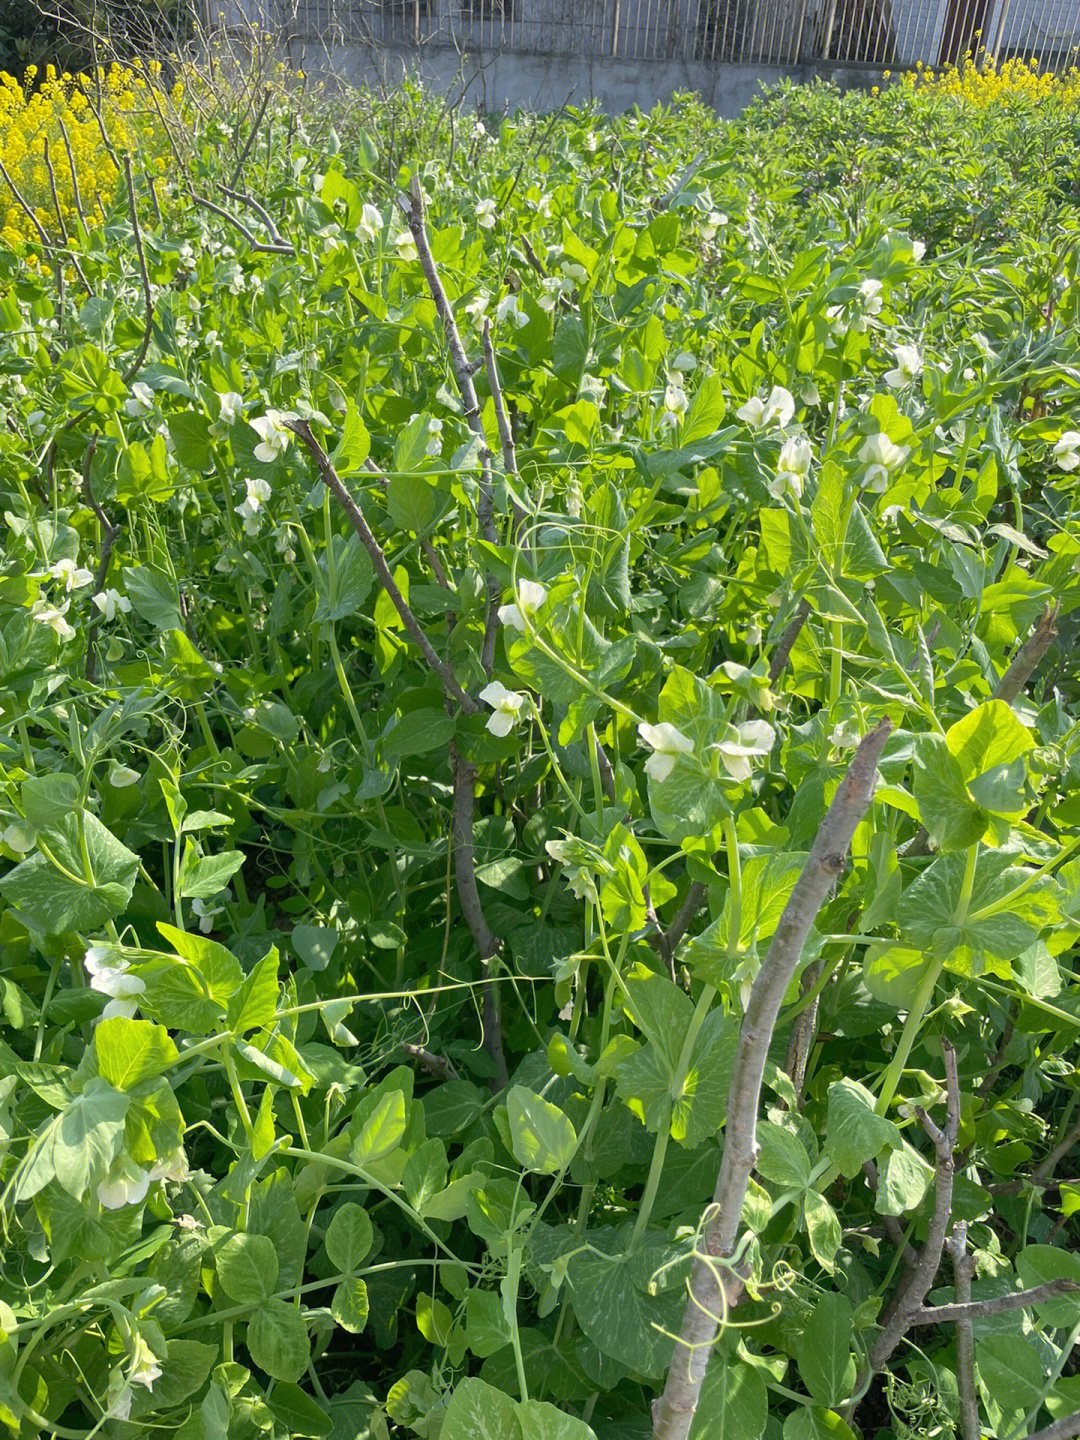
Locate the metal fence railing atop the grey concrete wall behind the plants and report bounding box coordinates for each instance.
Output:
[289,0,1080,71]
